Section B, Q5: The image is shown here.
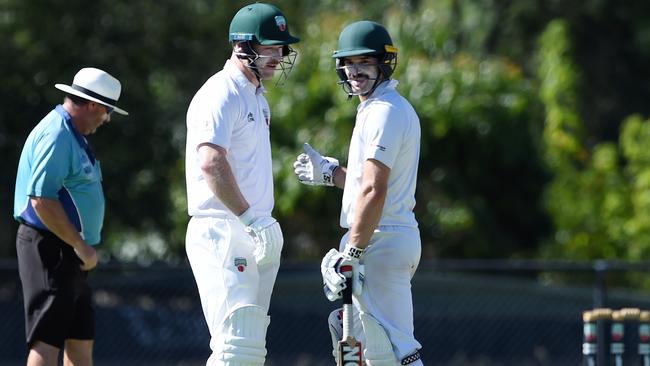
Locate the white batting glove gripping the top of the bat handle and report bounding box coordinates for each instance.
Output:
[320,244,364,301]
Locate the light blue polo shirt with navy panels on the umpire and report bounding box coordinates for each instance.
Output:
[14,105,105,245]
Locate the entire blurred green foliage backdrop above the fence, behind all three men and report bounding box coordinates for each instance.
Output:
[0,0,650,261]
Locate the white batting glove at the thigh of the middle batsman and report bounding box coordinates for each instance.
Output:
[239,209,284,266]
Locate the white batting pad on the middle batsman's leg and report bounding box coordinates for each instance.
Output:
[218,305,270,366]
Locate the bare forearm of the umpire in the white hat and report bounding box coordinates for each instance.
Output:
[30,197,86,249]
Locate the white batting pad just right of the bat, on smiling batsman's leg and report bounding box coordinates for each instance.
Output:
[359,313,400,366]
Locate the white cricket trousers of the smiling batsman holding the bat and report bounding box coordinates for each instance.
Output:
[339,226,422,365]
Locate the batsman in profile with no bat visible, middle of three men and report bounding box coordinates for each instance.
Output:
[186,3,299,366]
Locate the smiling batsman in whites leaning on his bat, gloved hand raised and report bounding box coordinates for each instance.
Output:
[294,21,423,366]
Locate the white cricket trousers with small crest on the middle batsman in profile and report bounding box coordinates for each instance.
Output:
[185,217,280,364]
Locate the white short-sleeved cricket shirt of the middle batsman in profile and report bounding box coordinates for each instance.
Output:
[185,60,273,217]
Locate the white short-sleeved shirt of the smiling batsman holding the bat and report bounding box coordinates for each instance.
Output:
[341,80,420,228]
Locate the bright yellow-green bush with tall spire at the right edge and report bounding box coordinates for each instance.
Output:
[540,22,650,259]
